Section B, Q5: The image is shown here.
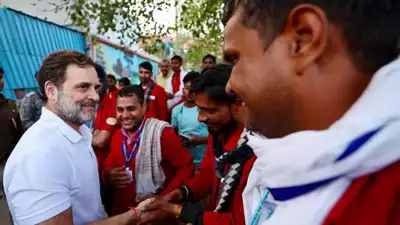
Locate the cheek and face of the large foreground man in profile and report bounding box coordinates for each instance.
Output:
[225,10,295,137]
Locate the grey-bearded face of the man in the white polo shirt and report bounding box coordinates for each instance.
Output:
[45,64,101,125]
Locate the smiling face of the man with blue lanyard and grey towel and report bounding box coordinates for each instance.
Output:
[117,95,147,132]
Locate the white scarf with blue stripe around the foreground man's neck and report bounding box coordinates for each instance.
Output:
[243,61,400,225]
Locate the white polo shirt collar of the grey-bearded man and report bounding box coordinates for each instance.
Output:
[41,107,92,144]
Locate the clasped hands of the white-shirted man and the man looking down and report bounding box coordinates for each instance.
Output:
[134,190,187,225]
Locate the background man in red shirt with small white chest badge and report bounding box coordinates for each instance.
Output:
[139,62,169,121]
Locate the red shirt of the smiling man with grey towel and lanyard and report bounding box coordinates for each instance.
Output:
[103,122,194,215]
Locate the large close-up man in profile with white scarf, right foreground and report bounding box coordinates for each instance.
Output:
[224,0,400,225]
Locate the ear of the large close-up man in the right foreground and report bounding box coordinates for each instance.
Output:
[284,4,329,74]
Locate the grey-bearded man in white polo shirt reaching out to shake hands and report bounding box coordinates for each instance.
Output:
[4,51,145,225]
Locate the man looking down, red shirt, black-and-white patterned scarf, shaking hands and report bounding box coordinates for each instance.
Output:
[136,65,255,225]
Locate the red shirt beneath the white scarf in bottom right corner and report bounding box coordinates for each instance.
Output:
[323,161,400,225]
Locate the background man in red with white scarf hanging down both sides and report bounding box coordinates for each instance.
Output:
[165,55,186,110]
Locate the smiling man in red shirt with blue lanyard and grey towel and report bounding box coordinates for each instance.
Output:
[103,85,194,215]
